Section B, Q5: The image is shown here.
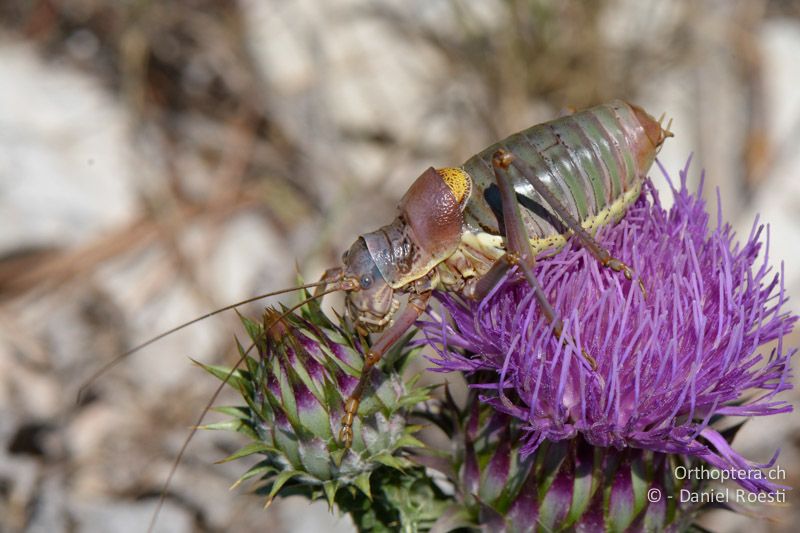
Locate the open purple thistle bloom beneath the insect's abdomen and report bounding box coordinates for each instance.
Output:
[421,158,797,491]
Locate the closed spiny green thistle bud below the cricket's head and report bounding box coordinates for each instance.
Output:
[204,301,443,531]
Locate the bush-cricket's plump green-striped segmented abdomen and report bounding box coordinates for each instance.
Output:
[462,101,655,249]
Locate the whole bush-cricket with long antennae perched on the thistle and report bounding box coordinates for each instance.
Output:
[82,100,672,454]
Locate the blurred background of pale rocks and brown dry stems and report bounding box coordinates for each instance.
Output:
[0,0,800,533]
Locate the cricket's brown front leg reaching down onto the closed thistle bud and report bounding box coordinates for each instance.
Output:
[339,291,431,448]
